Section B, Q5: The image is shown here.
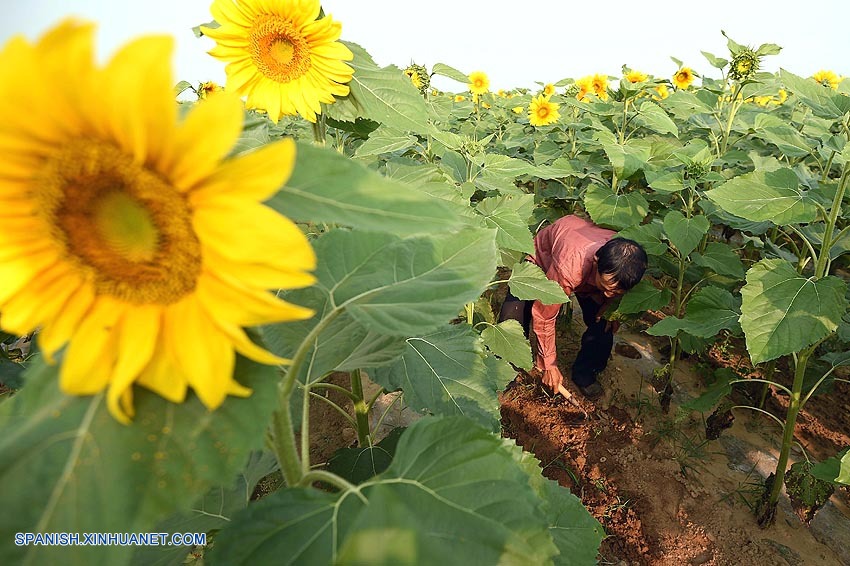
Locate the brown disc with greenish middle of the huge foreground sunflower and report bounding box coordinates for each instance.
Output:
[34,140,201,304]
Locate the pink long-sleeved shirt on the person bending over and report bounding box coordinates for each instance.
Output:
[531,216,616,370]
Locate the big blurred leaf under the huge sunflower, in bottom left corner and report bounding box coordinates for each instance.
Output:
[0,358,277,565]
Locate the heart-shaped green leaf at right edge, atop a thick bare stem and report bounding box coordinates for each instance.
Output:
[741,259,847,364]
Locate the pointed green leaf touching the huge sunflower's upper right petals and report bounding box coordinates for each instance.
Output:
[267,144,462,239]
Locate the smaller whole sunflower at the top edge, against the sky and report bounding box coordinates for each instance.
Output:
[201,0,354,123]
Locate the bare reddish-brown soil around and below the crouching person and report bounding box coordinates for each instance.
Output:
[501,306,850,566]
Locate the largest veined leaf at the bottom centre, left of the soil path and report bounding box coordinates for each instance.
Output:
[209,418,564,566]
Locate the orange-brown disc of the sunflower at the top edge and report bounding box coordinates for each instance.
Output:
[250,16,311,83]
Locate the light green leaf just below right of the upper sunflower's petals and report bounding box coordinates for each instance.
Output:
[338,43,432,134]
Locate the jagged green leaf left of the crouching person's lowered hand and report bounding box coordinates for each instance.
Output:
[370,324,506,430]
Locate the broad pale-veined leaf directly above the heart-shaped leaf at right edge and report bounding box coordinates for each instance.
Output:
[705,167,817,225]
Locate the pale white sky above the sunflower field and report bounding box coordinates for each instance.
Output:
[0,0,850,91]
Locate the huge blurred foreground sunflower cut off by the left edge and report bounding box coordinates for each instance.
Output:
[0,20,315,422]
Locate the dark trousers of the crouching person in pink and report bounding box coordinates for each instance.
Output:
[499,293,614,387]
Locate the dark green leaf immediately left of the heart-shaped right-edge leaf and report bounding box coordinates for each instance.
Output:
[646,287,741,338]
